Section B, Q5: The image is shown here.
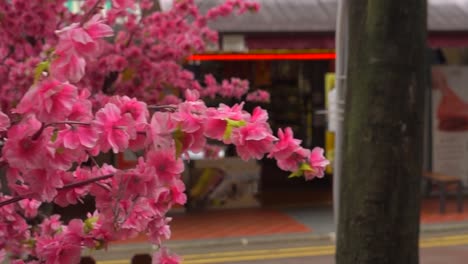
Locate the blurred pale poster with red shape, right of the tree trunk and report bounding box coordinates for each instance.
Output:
[432,66,468,184]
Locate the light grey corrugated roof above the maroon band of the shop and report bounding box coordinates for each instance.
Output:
[197,0,468,33]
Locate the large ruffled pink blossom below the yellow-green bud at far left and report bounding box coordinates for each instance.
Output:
[14,79,78,122]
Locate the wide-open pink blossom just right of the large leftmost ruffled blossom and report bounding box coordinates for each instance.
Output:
[93,103,136,153]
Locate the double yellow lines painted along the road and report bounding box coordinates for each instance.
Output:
[97,235,468,264]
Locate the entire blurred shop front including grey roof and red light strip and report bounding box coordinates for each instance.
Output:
[189,0,468,206]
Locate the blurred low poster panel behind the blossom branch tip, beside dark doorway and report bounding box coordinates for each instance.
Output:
[189,157,260,209]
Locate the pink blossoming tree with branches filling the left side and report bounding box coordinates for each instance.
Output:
[0,0,328,263]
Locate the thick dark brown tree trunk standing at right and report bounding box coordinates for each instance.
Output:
[336,0,427,264]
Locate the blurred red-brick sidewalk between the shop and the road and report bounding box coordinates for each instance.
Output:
[109,198,468,248]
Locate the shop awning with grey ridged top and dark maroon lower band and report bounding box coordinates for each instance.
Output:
[197,0,468,49]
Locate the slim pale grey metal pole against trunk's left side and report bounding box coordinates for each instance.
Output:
[333,0,349,232]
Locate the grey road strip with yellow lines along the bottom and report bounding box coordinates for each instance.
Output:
[92,233,468,264]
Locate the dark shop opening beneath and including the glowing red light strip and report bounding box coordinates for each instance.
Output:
[185,55,334,206]
